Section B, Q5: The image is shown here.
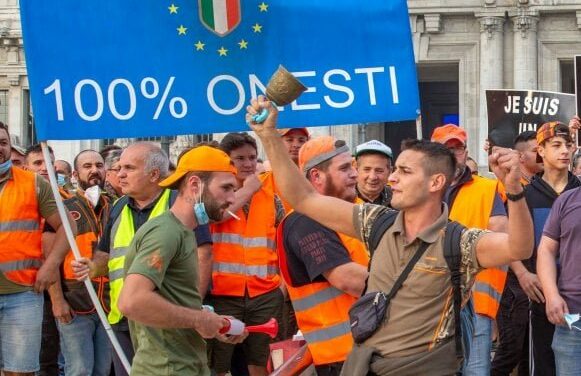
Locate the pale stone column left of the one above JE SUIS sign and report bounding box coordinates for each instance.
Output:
[476,15,504,167]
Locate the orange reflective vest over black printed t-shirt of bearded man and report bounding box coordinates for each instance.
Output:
[277,216,369,366]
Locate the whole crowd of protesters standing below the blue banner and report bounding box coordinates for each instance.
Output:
[0,97,581,376]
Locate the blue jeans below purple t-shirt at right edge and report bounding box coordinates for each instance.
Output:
[552,326,581,376]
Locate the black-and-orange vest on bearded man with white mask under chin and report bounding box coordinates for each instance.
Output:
[62,195,109,314]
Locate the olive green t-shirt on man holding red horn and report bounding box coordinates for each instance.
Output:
[125,211,210,376]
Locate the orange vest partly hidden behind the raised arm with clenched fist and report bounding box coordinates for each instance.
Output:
[449,176,508,320]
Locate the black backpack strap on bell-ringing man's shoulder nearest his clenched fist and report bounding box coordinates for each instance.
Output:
[444,221,466,358]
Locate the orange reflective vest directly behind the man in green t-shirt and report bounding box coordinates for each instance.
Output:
[211,176,280,298]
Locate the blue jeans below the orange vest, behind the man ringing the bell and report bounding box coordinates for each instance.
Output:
[464,313,492,376]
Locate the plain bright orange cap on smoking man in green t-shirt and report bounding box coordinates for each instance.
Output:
[159,145,237,188]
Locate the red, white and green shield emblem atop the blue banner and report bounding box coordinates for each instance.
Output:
[199,0,240,36]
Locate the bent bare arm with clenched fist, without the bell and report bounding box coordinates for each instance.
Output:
[476,148,534,268]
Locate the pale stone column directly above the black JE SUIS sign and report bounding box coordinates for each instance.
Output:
[512,10,539,90]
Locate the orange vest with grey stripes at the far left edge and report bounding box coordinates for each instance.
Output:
[0,167,43,286]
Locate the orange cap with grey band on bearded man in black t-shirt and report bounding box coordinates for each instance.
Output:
[299,136,349,174]
